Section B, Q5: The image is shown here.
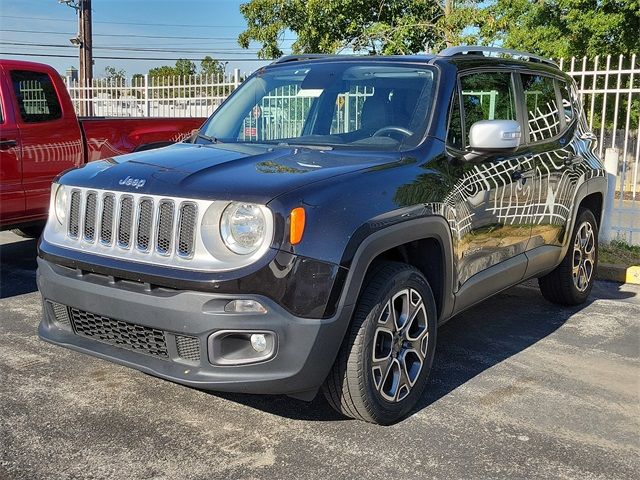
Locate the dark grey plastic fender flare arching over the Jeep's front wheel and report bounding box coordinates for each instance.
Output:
[338,215,454,322]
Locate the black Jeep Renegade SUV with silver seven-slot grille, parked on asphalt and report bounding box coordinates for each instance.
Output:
[38,47,606,424]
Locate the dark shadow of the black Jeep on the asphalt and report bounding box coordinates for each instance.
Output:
[215,281,635,421]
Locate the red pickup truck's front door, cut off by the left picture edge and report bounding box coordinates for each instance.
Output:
[0,67,24,224]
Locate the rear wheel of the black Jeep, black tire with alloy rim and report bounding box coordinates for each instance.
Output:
[538,208,598,306]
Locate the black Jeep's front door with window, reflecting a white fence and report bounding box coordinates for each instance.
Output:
[445,71,532,287]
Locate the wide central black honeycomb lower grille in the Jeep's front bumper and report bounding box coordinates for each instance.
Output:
[69,308,169,358]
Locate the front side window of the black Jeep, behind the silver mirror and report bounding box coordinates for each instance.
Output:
[460,72,516,145]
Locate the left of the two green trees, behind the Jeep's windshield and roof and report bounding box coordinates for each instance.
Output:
[238,0,484,58]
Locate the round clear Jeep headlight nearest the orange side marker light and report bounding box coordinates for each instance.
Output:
[220,202,266,255]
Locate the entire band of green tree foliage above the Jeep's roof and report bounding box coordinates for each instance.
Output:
[238,0,640,58]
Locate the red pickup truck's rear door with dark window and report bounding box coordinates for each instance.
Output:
[6,66,83,219]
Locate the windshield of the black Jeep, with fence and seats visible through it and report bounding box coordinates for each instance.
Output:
[201,61,434,150]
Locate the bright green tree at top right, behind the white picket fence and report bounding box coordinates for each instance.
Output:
[480,0,640,58]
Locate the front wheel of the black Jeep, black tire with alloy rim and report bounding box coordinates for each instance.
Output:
[322,262,437,425]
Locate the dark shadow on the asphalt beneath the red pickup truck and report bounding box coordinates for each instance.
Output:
[0,234,38,298]
